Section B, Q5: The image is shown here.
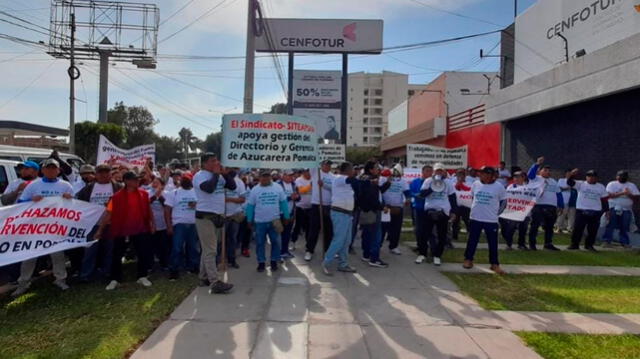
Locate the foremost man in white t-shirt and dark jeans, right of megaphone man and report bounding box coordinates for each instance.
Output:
[463,166,506,274]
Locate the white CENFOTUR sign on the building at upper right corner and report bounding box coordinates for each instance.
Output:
[515,0,640,83]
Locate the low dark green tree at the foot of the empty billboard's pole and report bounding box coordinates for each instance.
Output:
[75,121,125,163]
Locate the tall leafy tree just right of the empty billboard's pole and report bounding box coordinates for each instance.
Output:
[107,102,158,148]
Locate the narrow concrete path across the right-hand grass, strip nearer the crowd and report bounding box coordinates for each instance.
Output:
[437,263,640,276]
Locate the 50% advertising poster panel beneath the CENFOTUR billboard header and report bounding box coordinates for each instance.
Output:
[293,70,342,141]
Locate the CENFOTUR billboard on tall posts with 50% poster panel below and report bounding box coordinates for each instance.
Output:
[255,19,383,144]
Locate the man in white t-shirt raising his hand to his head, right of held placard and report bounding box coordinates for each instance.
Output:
[528,157,565,251]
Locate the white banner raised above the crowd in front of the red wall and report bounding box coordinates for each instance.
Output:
[407,144,468,170]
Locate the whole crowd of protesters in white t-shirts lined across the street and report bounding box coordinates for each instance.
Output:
[0,153,640,296]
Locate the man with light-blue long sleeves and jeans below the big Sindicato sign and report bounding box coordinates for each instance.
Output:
[246,171,290,272]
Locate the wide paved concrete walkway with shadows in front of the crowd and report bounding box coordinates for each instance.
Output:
[132,248,540,359]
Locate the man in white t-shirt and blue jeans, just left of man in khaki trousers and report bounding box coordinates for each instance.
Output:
[164,173,200,280]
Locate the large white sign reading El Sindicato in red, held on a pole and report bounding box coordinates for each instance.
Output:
[222,114,318,169]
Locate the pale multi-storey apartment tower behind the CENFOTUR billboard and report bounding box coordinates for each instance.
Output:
[347,71,424,146]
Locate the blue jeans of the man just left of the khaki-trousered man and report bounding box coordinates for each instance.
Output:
[169,223,200,271]
